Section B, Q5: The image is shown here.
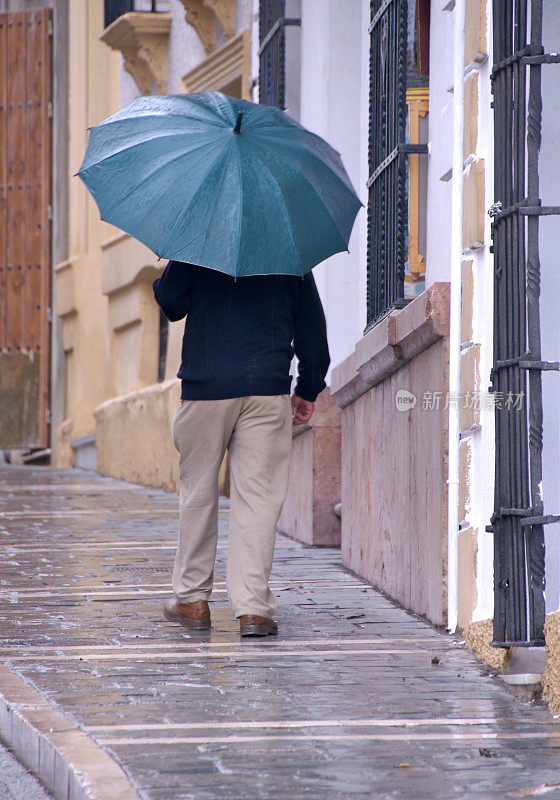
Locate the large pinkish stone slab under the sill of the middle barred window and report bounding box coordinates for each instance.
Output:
[342,337,449,625]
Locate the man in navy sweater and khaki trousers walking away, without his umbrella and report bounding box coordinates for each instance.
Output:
[154,261,330,636]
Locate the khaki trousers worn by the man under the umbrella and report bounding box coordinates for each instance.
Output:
[172,394,292,618]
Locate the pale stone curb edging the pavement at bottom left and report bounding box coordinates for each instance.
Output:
[0,663,140,800]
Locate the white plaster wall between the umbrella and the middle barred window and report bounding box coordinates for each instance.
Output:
[300,0,369,374]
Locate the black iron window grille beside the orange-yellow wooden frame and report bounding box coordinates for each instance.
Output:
[366,0,428,331]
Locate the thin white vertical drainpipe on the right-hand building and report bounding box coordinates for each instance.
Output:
[447,0,465,631]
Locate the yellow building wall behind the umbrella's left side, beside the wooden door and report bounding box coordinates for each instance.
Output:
[53,0,251,476]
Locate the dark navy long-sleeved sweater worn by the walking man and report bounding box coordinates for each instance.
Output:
[154,261,330,401]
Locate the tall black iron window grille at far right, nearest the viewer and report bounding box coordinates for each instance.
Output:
[487,0,560,647]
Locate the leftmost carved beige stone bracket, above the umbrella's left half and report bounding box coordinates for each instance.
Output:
[100,11,171,94]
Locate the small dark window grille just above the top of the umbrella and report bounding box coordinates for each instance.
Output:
[259,0,301,110]
